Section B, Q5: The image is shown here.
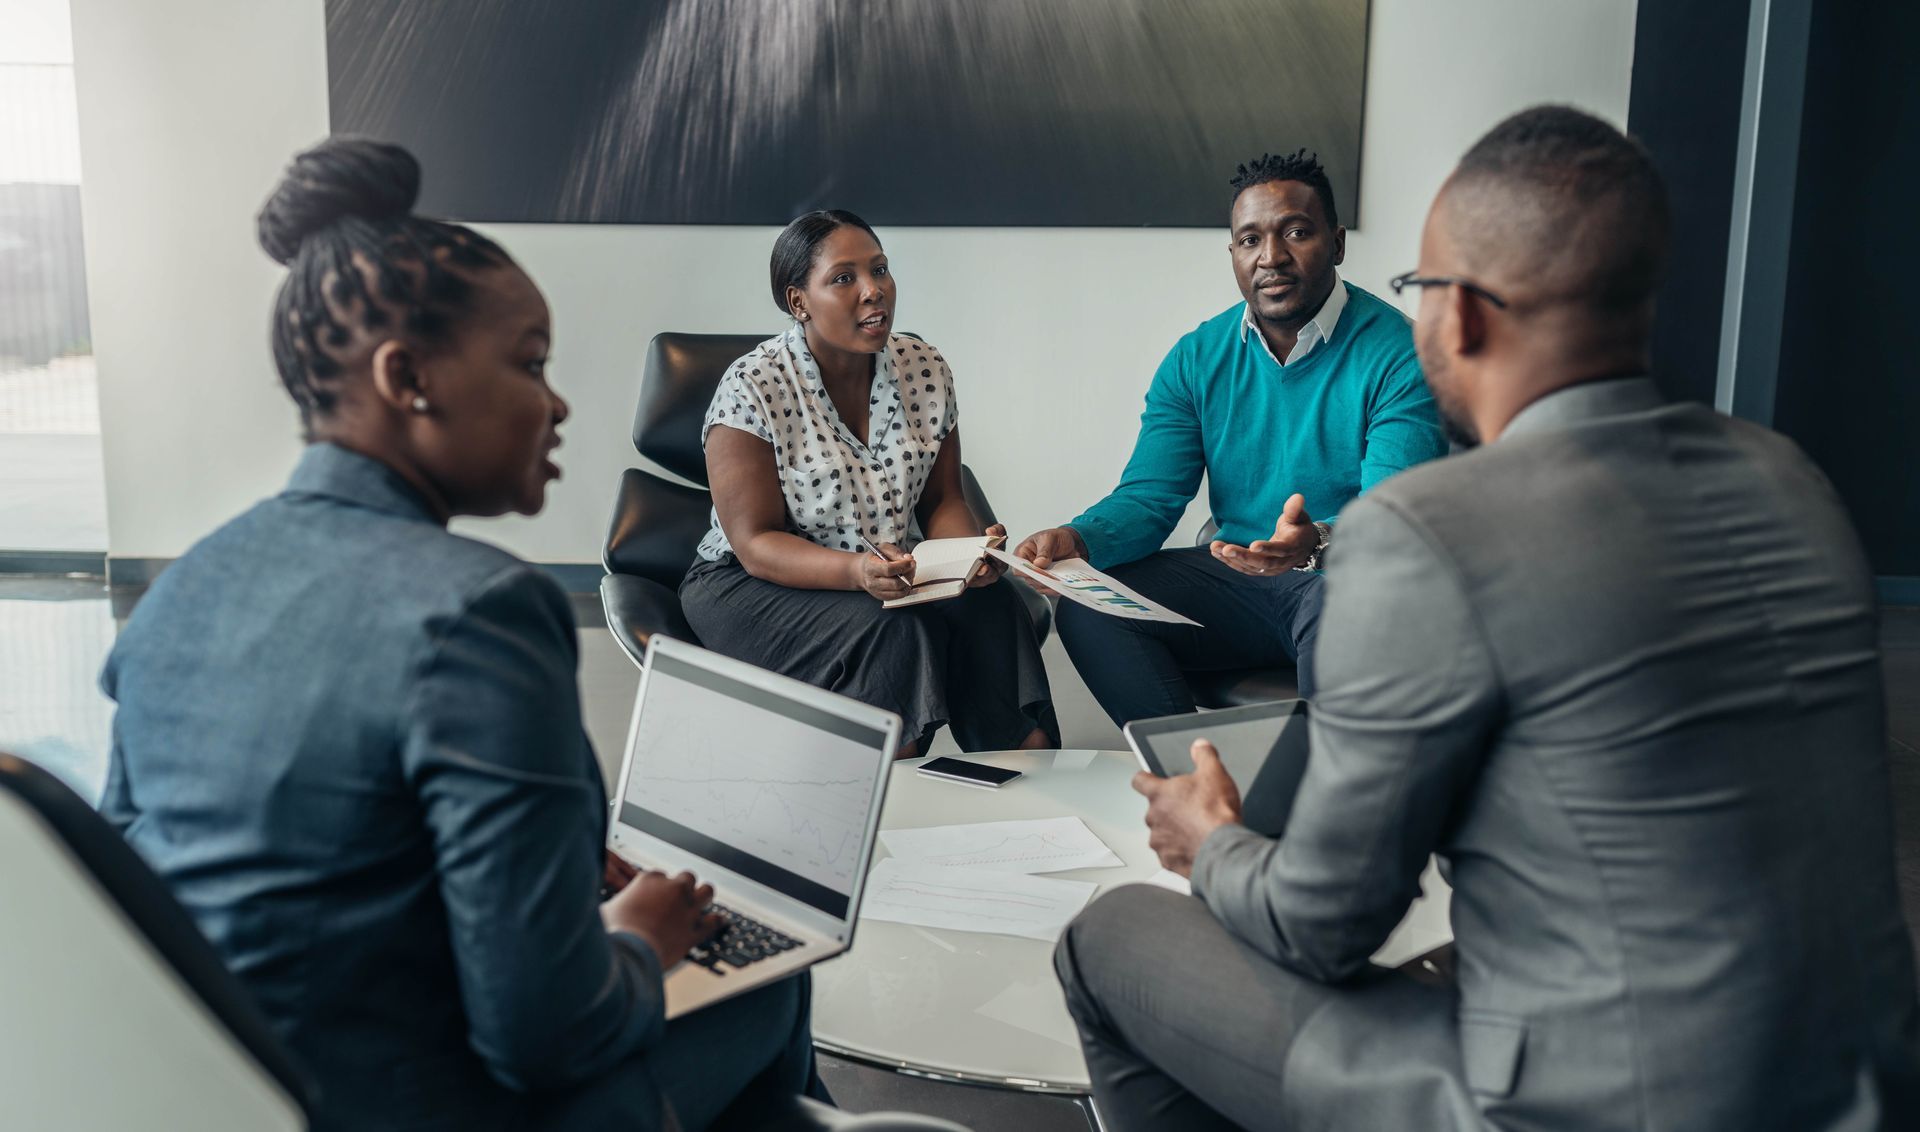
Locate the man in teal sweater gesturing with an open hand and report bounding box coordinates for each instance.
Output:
[1016,152,1446,723]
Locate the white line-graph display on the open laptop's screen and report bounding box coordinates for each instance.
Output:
[626,666,883,894]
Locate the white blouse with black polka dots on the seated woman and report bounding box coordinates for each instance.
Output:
[699,324,958,562]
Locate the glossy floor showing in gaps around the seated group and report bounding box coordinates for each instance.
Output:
[0,578,1920,1132]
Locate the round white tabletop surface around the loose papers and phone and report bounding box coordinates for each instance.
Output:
[814,750,1160,1094]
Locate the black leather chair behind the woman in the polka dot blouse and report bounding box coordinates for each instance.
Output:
[601,334,1052,664]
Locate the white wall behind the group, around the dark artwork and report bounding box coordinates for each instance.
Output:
[73,0,1634,562]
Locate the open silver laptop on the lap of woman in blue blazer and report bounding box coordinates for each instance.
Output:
[607,633,900,1019]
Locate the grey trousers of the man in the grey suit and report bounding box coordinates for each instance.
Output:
[1054,884,1486,1132]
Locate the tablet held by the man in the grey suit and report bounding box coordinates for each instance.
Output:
[1123,700,1308,837]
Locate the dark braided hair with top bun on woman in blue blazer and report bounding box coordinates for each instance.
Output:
[257,136,513,439]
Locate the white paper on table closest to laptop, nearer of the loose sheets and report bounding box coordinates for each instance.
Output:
[860,858,1098,942]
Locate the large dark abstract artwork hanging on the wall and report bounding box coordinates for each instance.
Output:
[326,0,1367,226]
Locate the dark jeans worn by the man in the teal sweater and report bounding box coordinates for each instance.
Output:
[1058,547,1323,723]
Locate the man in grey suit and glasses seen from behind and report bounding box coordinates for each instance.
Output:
[1056,107,1920,1132]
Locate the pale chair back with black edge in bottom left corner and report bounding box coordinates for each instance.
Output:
[0,754,313,1132]
